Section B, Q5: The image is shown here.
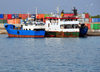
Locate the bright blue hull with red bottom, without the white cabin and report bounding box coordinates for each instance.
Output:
[4,24,45,37]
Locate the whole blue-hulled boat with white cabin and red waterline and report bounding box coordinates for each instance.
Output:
[4,18,45,38]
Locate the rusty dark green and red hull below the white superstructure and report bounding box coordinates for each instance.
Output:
[45,31,79,37]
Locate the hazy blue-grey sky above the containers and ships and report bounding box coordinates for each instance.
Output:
[0,0,100,15]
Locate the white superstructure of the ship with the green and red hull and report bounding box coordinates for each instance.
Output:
[45,18,79,32]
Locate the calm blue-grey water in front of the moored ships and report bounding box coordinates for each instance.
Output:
[0,35,100,72]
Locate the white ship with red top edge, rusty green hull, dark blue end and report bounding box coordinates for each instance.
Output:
[45,17,88,37]
